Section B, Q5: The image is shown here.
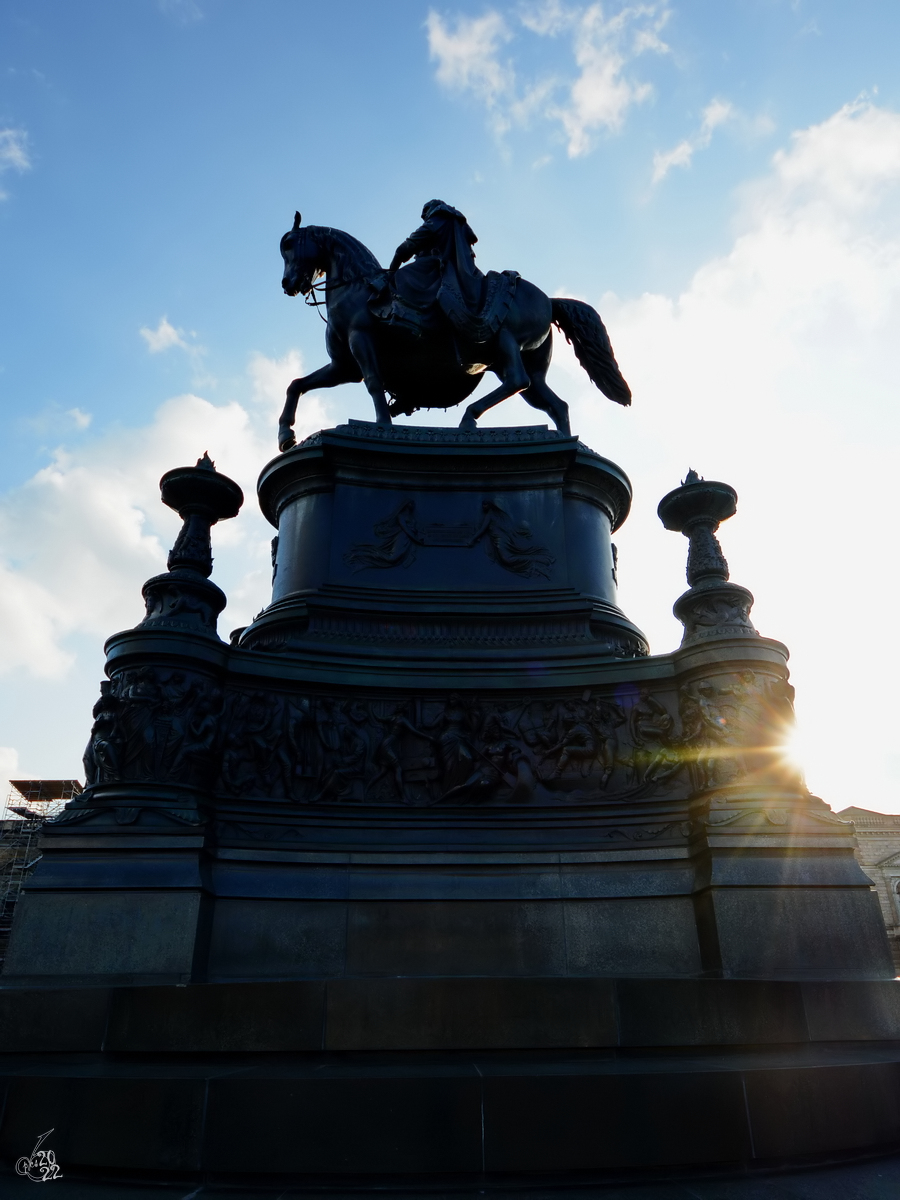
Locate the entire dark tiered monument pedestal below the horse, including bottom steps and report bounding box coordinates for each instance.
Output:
[0,425,900,1192]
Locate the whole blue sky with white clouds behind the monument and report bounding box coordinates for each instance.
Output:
[0,0,900,810]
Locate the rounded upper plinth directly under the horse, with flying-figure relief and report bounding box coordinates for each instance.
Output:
[240,421,647,688]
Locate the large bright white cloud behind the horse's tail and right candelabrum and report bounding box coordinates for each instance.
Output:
[556,102,900,811]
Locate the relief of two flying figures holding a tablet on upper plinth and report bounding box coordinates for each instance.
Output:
[343,500,556,578]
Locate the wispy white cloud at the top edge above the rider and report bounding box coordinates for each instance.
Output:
[426,0,668,157]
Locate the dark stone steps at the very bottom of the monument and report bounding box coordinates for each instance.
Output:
[0,978,900,1192]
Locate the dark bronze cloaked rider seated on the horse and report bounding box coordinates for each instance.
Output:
[390,200,485,320]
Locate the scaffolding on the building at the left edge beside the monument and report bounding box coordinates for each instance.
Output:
[0,779,82,970]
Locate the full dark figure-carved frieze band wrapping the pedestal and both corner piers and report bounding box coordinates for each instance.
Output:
[84,667,792,808]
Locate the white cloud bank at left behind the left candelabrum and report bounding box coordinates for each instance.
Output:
[0,352,328,679]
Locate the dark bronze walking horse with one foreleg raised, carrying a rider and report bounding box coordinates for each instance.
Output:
[278,202,631,450]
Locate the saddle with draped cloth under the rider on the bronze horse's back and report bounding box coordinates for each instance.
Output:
[368,256,520,344]
